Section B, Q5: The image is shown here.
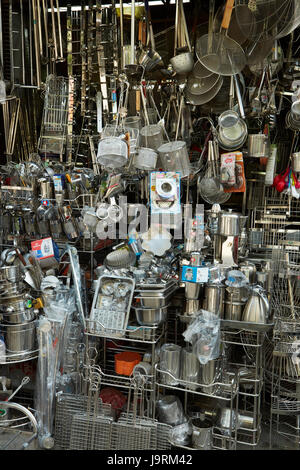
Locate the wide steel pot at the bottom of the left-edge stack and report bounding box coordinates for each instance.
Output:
[1,321,36,353]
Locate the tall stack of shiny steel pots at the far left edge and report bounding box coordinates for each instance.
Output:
[0,265,38,362]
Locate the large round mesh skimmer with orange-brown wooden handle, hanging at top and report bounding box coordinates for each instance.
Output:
[196,0,246,75]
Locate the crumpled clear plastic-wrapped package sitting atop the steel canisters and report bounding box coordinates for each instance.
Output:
[183,310,221,364]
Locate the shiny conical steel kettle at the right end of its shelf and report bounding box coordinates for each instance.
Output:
[242,285,270,323]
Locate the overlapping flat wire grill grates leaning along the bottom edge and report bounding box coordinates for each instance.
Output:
[54,394,171,450]
